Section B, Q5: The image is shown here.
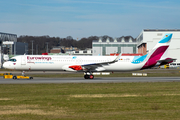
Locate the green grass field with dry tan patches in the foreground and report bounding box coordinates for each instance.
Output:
[0,82,180,120]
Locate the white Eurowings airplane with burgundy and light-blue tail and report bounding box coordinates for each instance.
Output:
[3,33,175,79]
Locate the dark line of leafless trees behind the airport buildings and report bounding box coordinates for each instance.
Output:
[17,35,134,54]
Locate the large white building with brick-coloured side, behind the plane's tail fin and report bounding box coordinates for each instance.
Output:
[136,29,180,66]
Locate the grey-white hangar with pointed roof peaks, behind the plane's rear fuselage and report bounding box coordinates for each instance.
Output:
[92,36,137,56]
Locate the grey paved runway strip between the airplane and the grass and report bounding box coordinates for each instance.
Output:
[0,77,180,84]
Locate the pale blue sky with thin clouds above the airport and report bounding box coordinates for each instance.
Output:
[0,0,180,39]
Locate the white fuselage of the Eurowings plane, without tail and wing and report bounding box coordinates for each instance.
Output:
[3,55,146,71]
